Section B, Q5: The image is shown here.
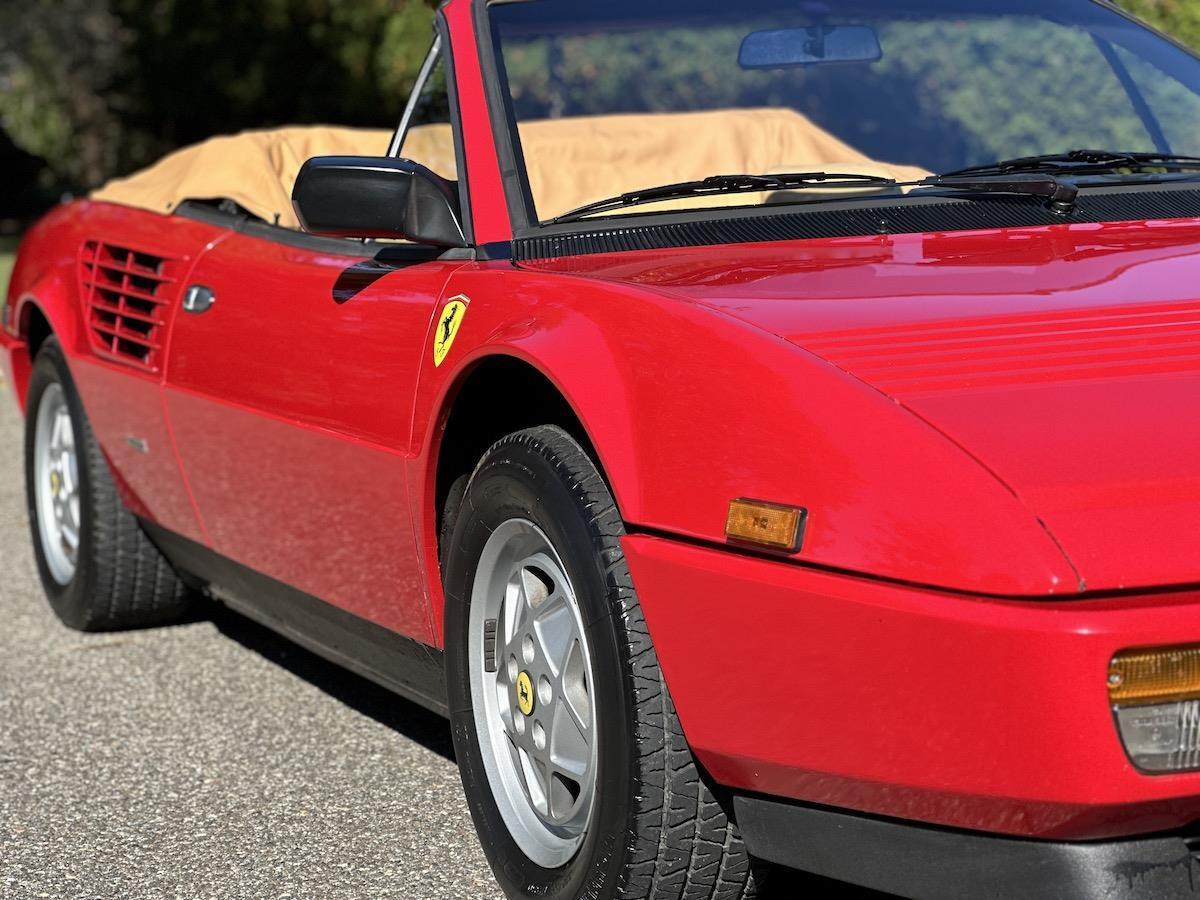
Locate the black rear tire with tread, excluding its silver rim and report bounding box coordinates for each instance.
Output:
[25,338,193,631]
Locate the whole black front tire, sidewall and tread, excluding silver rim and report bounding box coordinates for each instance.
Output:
[445,426,756,900]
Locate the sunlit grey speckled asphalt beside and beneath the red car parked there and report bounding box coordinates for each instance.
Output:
[0,384,873,900]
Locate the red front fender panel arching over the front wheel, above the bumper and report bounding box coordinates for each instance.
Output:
[414,266,1079,643]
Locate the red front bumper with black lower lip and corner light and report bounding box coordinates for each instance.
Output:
[626,538,1200,896]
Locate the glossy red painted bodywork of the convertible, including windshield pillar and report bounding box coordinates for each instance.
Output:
[11,0,1200,897]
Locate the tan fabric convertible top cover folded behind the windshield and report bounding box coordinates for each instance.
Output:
[92,109,928,228]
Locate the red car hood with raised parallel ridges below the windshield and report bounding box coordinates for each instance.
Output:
[535,221,1200,590]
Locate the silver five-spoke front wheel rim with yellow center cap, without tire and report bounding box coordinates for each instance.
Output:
[469,518,596,869]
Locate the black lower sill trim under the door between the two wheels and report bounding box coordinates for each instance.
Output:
[142,521,449,715]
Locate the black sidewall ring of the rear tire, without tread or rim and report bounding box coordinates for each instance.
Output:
[25,338,94,629]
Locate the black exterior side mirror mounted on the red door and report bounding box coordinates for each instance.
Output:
[292,156,467,247]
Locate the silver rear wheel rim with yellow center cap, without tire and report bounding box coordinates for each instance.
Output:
[34,384,80,586]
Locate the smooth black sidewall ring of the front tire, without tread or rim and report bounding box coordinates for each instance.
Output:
[445,439,634,898]
